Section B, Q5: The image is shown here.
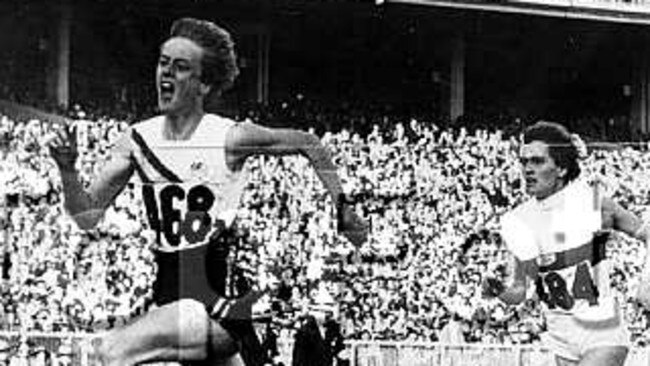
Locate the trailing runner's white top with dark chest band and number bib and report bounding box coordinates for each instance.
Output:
[502,179,617,321]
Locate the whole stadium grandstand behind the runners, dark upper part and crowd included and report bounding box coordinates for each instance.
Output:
[0,0,650,366]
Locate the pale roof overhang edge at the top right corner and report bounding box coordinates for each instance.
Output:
[376,0,650,25]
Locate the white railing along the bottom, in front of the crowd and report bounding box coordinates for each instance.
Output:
[0,332,650,366]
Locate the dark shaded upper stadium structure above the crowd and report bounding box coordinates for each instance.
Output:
[0,0,650,139]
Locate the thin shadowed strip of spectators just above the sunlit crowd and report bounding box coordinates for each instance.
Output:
[0,85,636,142]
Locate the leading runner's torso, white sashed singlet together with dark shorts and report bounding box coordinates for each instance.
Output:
[127,114,249,309]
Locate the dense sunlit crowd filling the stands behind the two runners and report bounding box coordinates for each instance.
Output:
[0,98,650,364]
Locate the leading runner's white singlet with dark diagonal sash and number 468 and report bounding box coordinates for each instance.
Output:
[130,114,243,252]
